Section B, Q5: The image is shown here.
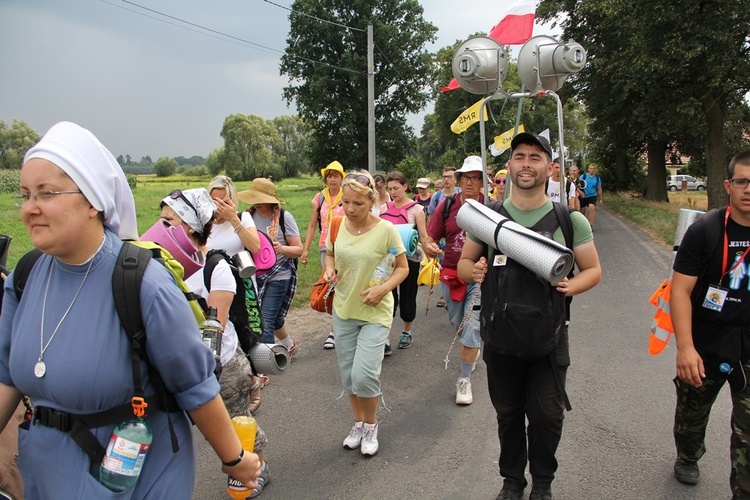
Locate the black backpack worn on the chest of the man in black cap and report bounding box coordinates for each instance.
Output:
[480,201,573,409]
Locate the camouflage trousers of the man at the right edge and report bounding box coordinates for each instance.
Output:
[674,362,750,498]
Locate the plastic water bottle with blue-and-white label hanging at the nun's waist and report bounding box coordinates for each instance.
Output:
[99,418,153,493]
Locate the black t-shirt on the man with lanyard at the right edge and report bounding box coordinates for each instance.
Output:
[673,209,750,356]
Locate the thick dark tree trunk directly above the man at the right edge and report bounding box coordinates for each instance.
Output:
[701,90,729,210]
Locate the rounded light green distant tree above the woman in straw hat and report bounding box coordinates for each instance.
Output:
[221,114,283,181]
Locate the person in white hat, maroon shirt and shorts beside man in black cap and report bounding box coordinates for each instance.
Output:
[424,156,484,405]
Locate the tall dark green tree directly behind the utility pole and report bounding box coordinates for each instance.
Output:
[281,0,437,170]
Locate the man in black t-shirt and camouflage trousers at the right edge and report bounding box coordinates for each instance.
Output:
[670,151,750,499]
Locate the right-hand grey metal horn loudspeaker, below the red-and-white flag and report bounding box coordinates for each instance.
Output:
[520,35,586,92]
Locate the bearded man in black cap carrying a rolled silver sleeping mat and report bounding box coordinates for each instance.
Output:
[458,133,602,500]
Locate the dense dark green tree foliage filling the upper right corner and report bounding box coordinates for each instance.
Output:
[537,0,750,207]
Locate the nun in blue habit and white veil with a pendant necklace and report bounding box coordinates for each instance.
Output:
[0,122,259,499]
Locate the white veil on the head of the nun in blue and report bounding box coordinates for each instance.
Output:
[23,122,138,240]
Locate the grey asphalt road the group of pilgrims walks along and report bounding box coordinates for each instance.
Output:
[194,209,731,500]
